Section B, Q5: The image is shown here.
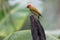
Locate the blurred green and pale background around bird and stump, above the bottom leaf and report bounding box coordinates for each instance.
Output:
[0,0,60,40]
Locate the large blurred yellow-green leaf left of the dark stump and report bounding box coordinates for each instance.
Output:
[0,0,28,37]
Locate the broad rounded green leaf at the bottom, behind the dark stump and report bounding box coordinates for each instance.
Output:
[4,30,59,40]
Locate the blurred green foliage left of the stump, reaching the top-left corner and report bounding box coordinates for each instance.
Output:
[0,0,28,36]
